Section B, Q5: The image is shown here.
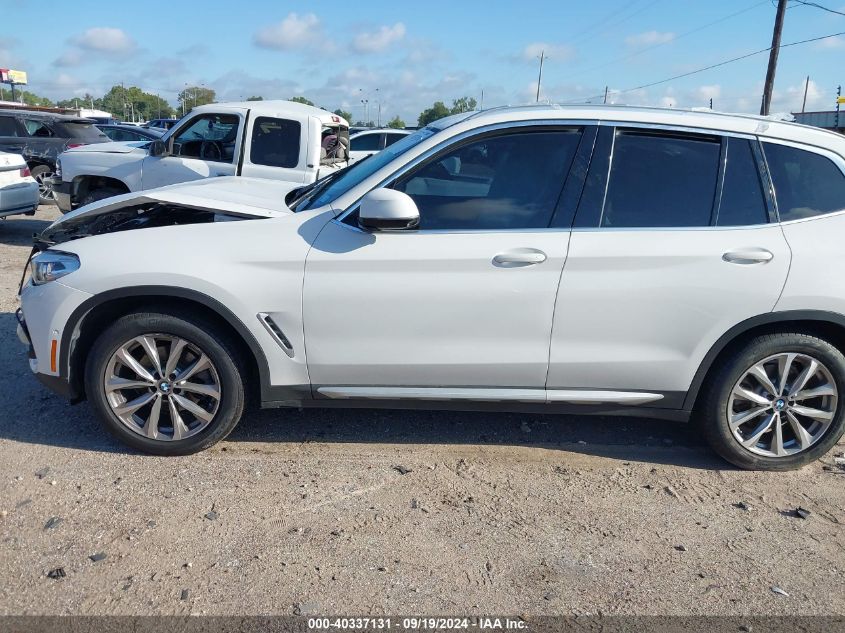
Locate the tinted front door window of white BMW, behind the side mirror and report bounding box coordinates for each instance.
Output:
[394,129,581,230]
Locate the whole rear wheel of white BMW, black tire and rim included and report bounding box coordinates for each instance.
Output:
[697,333,845,471]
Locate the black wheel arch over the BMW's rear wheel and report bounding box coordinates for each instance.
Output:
[684,310,845,411]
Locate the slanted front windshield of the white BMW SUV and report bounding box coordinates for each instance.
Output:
[294,127,439,211]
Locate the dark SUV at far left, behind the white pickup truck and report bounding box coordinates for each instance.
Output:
[0,109,109,204]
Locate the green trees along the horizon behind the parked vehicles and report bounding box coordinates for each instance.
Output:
[0,84,477,129]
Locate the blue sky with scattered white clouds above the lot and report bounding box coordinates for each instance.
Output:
[0,0,845,123]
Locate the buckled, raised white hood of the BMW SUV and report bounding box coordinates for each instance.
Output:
[42,176,297,245]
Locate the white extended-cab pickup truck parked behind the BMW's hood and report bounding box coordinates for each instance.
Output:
[53,101,349,213]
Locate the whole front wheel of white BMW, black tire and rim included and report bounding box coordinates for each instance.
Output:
[85,311,244,455]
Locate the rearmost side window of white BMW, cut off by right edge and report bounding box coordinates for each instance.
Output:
[763,143,845,222]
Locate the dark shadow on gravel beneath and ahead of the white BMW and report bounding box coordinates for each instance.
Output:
[0,313,727,469]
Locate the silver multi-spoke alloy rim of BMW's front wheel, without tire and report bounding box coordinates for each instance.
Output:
[103,334,222,441]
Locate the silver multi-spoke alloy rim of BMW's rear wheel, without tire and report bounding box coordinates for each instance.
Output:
[727,352,839,457]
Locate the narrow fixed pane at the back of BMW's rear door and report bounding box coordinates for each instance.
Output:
[716,138,768,226]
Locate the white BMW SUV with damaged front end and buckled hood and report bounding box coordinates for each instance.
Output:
[18,107,845,470]
